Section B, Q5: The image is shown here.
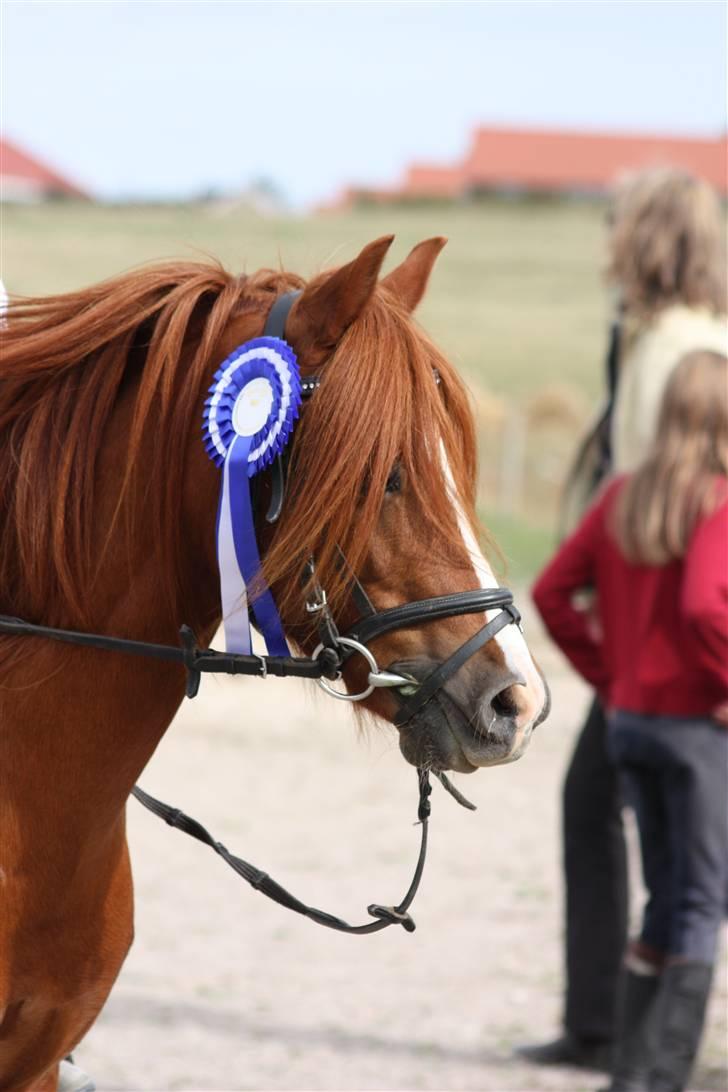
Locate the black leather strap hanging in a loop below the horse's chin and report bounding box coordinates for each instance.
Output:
[132,769,432,936]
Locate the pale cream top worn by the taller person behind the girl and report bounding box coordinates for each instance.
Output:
[611,305,728,474]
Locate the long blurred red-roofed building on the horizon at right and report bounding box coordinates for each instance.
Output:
[332,127,728,207]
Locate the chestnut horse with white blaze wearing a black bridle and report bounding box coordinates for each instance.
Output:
[0,237,547,1092]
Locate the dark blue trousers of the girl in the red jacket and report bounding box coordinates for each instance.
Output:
[608,710,728,963]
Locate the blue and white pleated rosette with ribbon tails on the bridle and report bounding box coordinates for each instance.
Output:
[203,337,301,656]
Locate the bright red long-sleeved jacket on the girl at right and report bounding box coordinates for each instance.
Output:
[534,478,728,716]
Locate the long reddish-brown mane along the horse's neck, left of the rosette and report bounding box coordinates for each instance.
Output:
[0,262,302,622]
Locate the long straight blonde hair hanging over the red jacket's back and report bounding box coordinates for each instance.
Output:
[612,351,728,565]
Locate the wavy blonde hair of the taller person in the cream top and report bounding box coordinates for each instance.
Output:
[607,167,728,321]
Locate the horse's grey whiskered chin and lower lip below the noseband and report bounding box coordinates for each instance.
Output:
[399,691,530,773]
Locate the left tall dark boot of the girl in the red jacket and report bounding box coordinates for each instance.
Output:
[604,969,660,1092]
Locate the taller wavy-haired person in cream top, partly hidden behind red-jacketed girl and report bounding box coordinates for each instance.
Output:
[518,167,728,1069]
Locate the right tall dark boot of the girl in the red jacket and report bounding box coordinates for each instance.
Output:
[648,962,713,1092]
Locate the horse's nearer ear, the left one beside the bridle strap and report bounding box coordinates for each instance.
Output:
[287,235,394,356]
